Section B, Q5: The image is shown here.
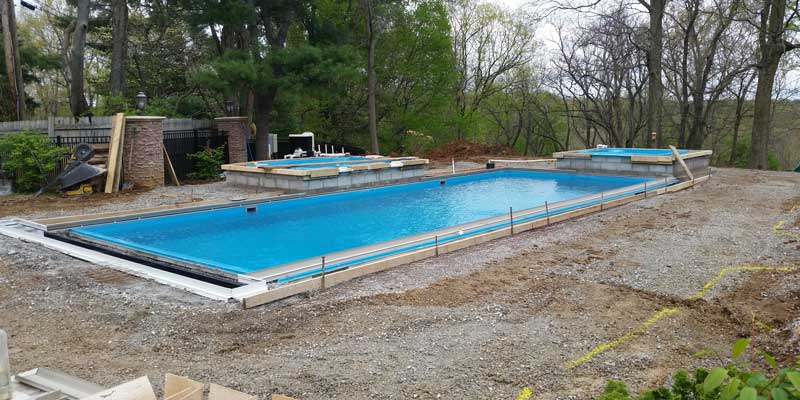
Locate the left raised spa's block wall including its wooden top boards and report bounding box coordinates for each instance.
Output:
[223,159,428,192]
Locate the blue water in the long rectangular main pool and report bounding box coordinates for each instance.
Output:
[72,170,664,273]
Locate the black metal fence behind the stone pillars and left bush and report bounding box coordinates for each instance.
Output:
[0,129,228,186]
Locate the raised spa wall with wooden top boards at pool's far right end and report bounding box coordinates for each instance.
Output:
[553,150,711,180]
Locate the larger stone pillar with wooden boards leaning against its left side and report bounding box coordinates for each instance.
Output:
[122,116,164,188]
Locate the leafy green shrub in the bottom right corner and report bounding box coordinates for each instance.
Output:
[599,339,800,400]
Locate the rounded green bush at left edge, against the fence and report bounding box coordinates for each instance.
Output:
[0,132,69,192]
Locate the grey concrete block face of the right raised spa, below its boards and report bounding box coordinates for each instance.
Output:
[556,156,710,178]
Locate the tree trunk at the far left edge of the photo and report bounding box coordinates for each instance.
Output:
[0,0,26,121]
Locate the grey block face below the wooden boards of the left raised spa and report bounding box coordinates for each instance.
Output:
[225,166,425,192]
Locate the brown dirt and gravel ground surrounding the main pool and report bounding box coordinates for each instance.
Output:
[0,169,800,399]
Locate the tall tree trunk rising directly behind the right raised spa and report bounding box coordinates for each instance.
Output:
[647,0,667,147]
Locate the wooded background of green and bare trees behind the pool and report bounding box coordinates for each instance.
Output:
[0,0,800,169]
